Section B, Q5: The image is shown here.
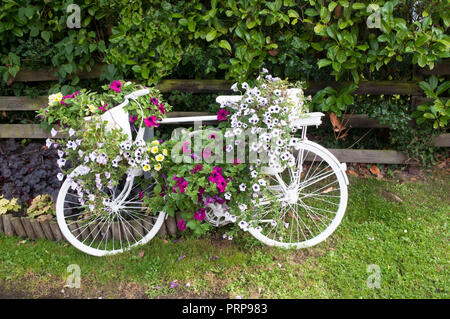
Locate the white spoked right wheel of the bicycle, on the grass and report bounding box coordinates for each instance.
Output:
[249,141,348,248]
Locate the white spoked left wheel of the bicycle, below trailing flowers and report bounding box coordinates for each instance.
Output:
[56,170,166,256]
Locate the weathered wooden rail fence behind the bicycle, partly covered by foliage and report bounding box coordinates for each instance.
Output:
[0,63,450,164]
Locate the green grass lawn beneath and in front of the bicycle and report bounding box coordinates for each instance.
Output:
[0,170,450,298]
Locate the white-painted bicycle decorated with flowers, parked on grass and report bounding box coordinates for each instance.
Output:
[56,90,348,256]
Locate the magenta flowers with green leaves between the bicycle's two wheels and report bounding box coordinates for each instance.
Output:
[146,129,250,234]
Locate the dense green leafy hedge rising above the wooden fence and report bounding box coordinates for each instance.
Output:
[0,0,450,126]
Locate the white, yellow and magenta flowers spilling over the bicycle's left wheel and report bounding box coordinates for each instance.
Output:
[45,81,168,218]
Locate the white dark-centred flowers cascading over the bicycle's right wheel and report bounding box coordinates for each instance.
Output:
[217,69,311,230]
